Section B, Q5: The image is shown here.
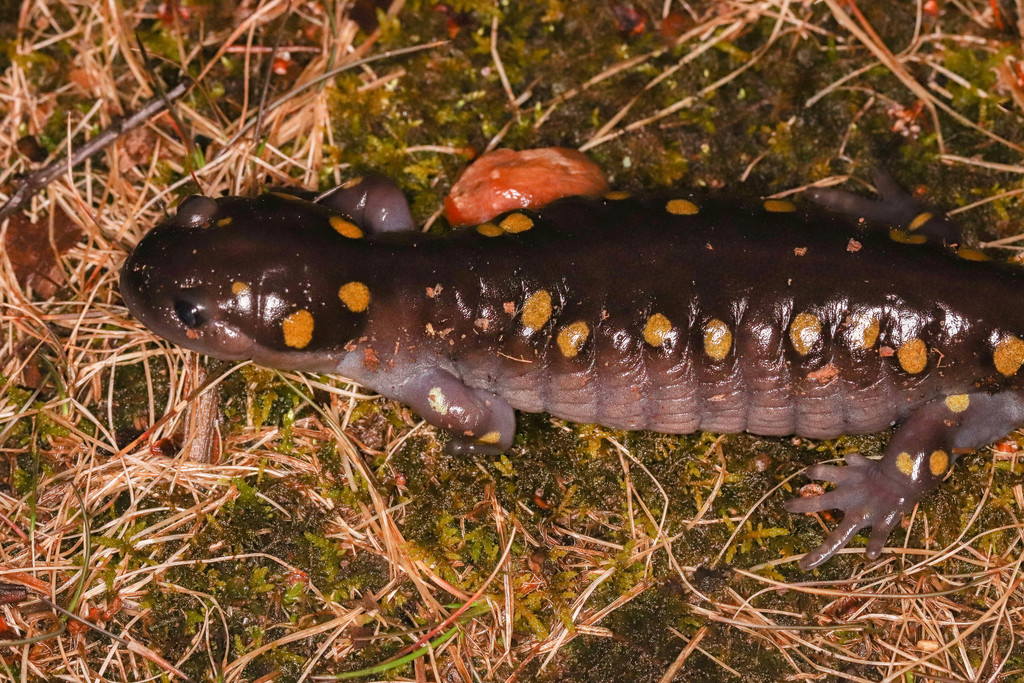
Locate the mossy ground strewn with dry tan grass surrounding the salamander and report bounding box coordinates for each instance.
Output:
[0,0,1024,682]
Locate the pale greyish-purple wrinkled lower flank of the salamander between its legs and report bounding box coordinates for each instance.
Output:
[466,344,913,438]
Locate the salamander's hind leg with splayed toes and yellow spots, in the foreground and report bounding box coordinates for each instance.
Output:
[785,391,1024,569]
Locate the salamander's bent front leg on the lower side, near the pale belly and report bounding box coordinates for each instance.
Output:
[394,368,515,456]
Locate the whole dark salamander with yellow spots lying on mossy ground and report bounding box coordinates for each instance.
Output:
[121,178,1024,568]
